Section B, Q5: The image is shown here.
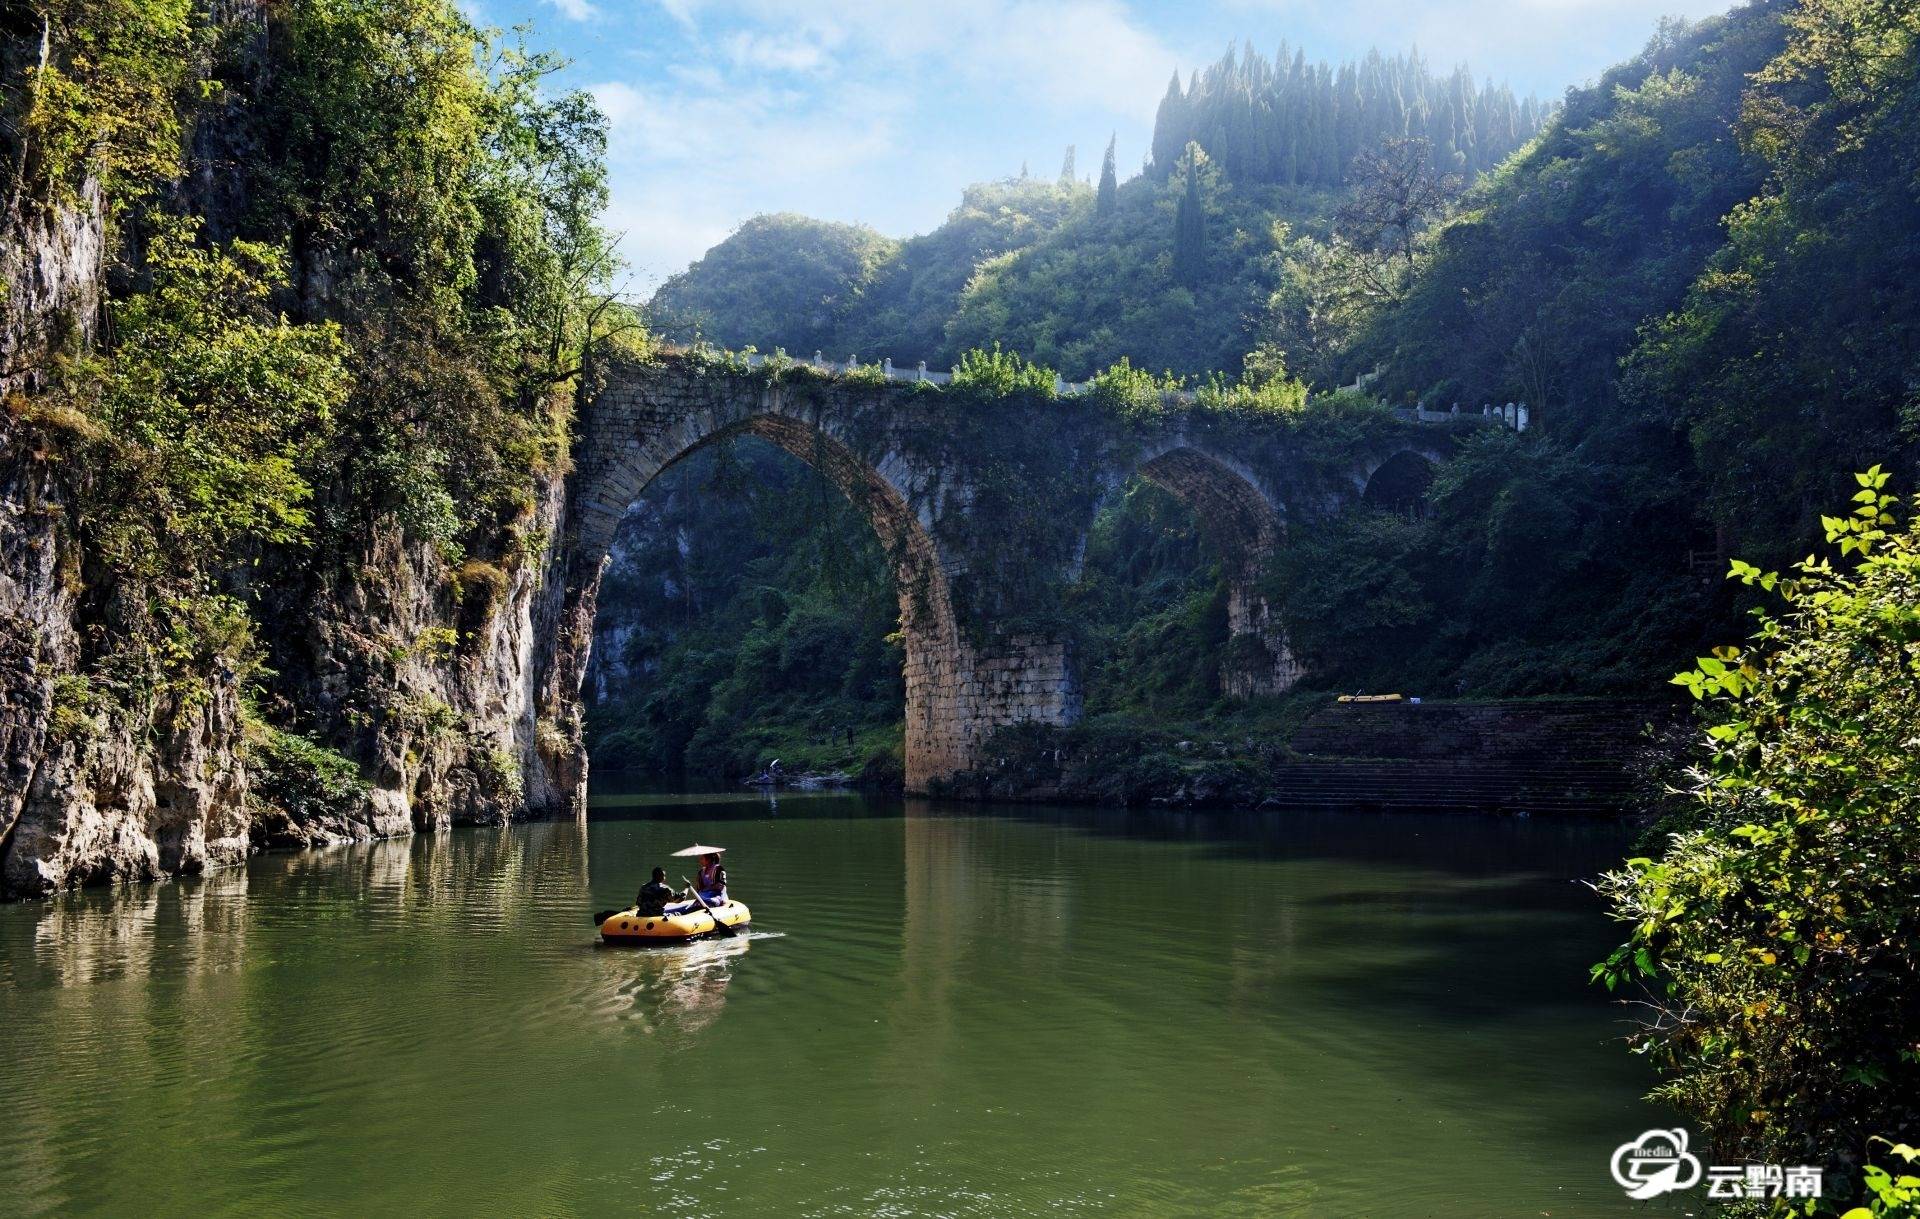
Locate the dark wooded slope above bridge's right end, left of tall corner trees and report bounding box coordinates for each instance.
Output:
[1338,6,1782,430]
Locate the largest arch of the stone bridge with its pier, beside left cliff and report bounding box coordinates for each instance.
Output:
[549,365,1079,791]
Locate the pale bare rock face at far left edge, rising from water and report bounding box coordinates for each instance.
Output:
[0,168,224,895]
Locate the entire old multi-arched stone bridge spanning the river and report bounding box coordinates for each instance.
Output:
[538,353,1476,791]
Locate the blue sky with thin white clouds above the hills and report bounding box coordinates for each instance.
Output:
[465,0,1730,294]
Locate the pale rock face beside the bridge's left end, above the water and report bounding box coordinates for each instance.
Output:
[236,478,584,860]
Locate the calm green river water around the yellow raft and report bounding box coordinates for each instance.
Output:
[0,793,1663,1219]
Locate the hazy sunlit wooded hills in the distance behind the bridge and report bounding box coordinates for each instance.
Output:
[653,46,1548,378]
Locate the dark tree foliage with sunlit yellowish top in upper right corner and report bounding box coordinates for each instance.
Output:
[1624,0,1920,562]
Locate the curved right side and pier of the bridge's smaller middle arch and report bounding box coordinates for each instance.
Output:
[1135,436,1302,699]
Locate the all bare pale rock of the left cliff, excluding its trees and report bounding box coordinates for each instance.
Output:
[0,2,586,896]
